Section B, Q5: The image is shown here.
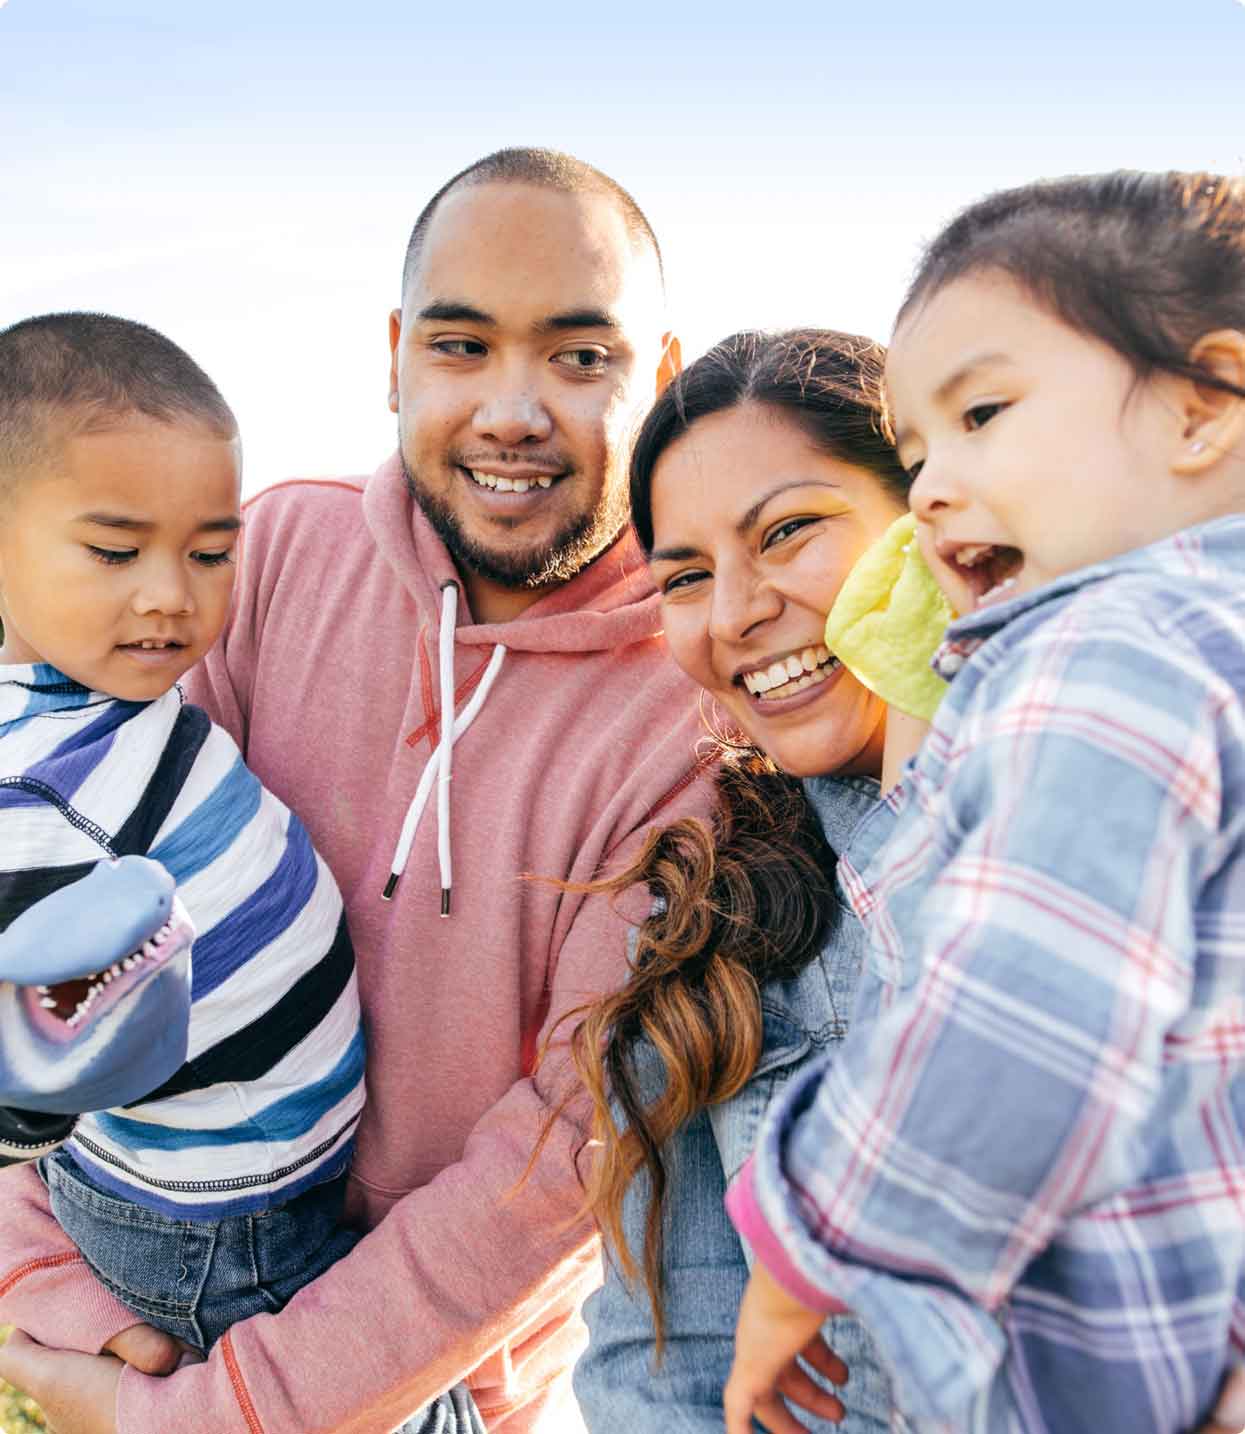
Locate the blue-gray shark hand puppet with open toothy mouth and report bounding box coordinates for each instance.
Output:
[0,856,195,1164]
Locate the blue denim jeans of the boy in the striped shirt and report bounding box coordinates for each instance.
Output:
[39,1149,483,1434]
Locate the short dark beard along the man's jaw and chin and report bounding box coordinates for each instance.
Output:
[402,453,628,591]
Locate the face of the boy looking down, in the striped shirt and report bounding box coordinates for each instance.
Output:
[0,414,241,701]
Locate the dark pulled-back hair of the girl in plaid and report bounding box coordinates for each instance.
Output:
[899,171,1245,397]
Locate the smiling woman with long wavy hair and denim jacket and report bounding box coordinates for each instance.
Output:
[574,330,908,1434]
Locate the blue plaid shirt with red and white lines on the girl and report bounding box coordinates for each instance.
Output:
[733,518,1245,1434]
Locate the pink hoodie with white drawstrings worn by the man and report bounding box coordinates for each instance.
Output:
[0,456,710,1434]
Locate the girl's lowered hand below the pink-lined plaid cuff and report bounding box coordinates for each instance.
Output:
[721,1263,846,1434]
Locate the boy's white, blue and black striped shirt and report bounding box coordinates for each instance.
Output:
[0,665,363,1220]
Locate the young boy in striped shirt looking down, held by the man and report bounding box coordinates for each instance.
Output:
[0,314,363,1349]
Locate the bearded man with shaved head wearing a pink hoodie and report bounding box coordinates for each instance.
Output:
[0,151,710,1434]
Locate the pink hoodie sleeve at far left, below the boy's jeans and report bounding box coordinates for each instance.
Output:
[0,1164,138,1354]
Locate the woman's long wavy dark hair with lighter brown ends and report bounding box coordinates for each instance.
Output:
[550,328,908,1355]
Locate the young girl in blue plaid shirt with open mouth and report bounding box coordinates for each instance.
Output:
[726,174,1245,1434]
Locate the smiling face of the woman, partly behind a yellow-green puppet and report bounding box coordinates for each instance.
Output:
[651,404,902,777]
